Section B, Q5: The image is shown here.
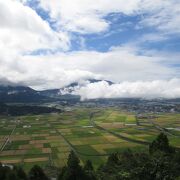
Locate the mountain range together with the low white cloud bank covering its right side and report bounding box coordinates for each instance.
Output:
[0,79,180,102]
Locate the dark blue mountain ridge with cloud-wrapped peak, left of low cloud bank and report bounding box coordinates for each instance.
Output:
[0,79,113,103]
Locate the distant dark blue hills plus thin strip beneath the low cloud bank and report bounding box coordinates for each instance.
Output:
[0,79,180,104]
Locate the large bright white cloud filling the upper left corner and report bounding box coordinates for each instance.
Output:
[0,0,70,54]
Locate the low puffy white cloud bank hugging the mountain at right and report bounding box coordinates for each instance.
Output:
[69,79,180,100]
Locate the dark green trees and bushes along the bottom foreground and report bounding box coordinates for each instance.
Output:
[0,133,180,180]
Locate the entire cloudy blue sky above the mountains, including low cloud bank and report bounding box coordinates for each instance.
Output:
[0,0,180,99]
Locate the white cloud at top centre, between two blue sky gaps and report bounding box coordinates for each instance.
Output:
[39,0,141,33]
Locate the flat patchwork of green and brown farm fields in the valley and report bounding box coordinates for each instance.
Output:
[0,107,180,170]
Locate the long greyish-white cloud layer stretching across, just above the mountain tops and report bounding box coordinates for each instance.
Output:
[0,46,179,89]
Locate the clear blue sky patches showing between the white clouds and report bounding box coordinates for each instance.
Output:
[25,0,180,55]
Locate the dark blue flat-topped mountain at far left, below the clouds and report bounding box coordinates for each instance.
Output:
[0,85,47,103]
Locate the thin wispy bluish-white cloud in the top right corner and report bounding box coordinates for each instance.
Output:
[140,0,180,34]
